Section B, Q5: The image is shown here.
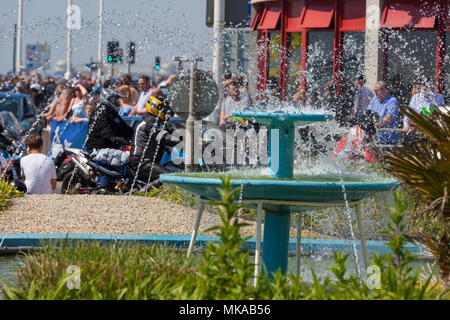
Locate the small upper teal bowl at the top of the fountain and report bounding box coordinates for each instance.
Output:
[233,110,333,128]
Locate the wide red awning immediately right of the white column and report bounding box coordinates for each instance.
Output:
[381,0,437,29]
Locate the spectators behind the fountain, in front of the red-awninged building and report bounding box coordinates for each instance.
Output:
[220,75,444,162]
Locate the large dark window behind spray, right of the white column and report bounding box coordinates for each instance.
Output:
[386,30,437,105]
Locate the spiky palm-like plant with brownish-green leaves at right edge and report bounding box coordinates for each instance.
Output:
[385,107,450,285]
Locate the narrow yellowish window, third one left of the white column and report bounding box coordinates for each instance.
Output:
[286,32,303,100]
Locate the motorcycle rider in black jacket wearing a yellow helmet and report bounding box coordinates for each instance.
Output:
[130,97,178,187]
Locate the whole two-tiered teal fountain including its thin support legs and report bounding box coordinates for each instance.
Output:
[160,110,397,275]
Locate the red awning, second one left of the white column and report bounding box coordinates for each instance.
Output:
[302,0,334,28]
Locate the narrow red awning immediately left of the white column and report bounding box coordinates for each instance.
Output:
[341,0,366,31]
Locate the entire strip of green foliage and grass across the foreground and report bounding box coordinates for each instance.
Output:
[3,178,449,300]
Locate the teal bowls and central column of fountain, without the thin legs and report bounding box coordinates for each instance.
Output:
[160,110,393,276]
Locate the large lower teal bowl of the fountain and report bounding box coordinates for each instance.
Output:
[160,173,398,207]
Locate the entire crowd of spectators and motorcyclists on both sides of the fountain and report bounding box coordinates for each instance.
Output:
[0,72,444,193]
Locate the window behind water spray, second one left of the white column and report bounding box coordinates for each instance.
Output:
[305,31,334,96]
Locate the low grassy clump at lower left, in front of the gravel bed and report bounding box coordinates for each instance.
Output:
[0,240,197,300]
